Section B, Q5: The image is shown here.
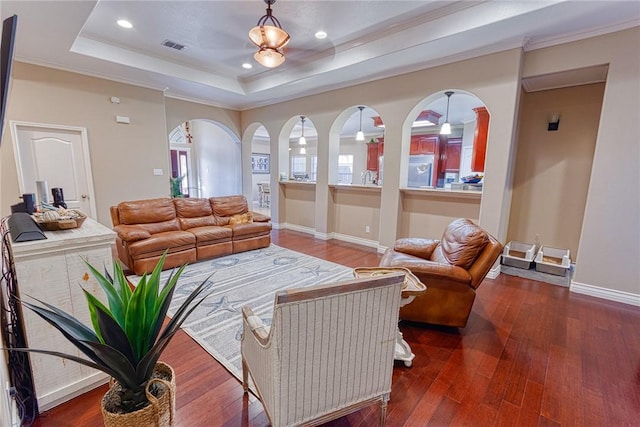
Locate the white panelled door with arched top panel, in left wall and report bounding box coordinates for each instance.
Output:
[11,122,96,219]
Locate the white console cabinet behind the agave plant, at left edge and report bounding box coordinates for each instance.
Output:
[11,218,115,411]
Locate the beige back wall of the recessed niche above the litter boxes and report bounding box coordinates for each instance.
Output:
[507,83,604,261]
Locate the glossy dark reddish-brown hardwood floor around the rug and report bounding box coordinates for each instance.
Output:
[35,230,640,427]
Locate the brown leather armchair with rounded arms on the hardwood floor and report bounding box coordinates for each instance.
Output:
[380,218,502,328]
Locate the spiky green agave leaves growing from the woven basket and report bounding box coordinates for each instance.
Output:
[14,252,210,412]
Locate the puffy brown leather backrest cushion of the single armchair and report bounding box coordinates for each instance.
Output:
[431,218,489,269]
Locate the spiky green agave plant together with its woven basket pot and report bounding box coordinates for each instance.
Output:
[12,252,210,427]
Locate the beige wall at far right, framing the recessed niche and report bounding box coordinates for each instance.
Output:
[523,27,640,298]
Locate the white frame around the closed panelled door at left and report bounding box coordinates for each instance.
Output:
[9,120,98,219]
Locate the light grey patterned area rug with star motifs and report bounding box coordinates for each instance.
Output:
[129,245,353,381]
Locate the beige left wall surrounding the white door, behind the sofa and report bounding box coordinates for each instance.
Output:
[0,62,169,226]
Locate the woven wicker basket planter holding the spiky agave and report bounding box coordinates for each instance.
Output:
[101,362,176,427]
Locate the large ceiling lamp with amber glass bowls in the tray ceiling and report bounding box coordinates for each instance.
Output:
[249,0,290,68]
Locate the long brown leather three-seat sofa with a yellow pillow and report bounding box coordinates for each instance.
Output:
[110,196,271,275]
